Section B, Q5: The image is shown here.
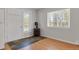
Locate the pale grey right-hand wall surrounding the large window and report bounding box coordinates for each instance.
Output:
[38,8,79,44]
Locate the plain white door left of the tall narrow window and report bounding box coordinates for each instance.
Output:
[5,8,22,42]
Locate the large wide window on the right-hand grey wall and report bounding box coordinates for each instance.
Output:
[47,9,70,28]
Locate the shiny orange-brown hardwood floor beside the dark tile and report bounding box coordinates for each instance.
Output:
[4,38,79,50]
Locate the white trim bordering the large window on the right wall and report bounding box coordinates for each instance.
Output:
[47,9,70,28]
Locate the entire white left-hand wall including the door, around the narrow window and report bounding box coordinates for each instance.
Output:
[0,8,36,49]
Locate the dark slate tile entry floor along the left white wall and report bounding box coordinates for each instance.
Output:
[7,37,43,50]
